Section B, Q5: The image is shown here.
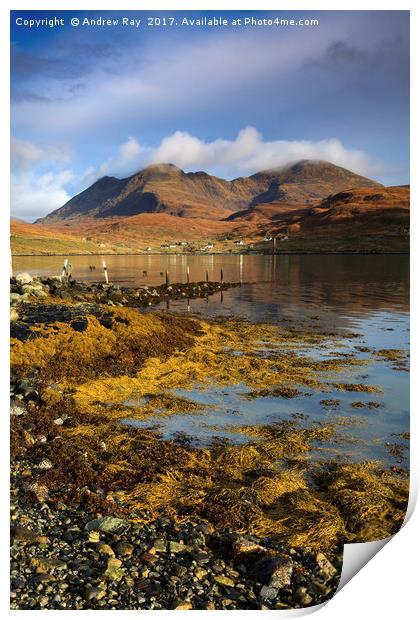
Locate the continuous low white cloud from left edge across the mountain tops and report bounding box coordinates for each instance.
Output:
[12,126,381,218]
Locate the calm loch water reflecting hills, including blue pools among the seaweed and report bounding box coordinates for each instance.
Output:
[14,255,409,463]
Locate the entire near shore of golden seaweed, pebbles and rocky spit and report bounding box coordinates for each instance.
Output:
[10,274,407,610]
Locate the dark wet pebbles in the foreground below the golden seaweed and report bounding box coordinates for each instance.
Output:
[11,460,341,610]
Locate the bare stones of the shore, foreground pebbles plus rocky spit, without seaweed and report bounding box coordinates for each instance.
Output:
[11,274,341,610]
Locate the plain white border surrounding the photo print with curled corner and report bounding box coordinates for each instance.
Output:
[0,0,420,620]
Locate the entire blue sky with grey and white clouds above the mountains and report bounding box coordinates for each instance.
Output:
[11,11,409,221]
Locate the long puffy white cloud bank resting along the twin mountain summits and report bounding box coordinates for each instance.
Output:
[83,127,381,185]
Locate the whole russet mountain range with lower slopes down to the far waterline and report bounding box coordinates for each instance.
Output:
[11,160,410,254]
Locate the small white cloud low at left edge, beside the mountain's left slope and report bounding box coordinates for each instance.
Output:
[11,170,73,220]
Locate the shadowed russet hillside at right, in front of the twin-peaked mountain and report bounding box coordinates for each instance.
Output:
[247,186,410,253]
